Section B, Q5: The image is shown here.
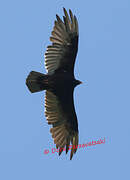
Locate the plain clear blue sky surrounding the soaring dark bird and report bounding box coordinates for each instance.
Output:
[0,0,130,180]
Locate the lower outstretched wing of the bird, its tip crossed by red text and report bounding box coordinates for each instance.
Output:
[45,91,78,159]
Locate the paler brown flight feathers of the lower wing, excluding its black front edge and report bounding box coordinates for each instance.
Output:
[45,91,78,159]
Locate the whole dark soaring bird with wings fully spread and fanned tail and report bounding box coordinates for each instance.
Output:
[26,8,82,159]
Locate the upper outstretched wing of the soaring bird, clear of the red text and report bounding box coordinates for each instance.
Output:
[45,8,78,74]
